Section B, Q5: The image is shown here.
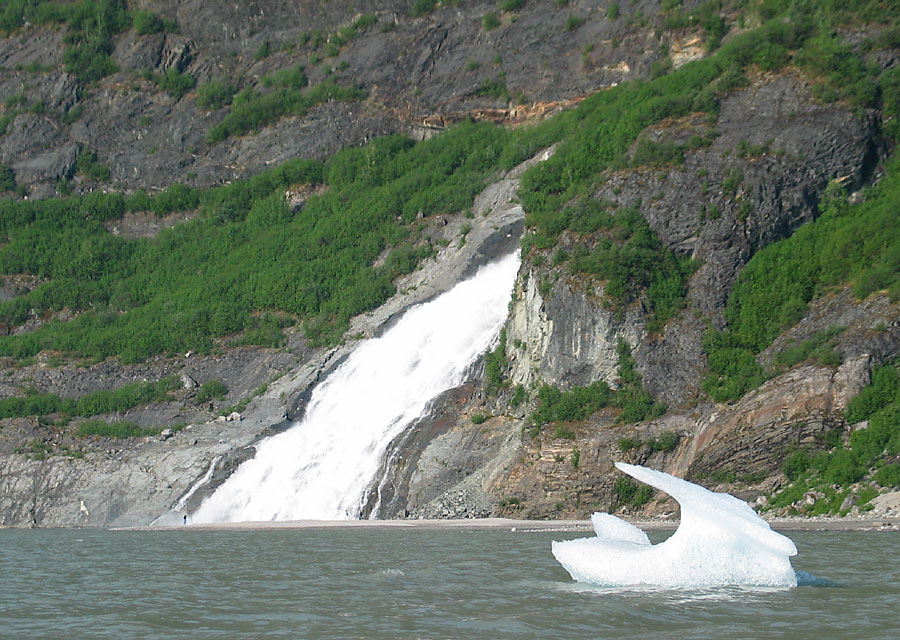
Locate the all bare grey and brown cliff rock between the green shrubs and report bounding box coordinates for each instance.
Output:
[0,0,900,526]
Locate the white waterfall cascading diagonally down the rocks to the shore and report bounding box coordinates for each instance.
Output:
[191,253,519,522]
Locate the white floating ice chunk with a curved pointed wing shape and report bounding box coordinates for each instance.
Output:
[553,462,797,588]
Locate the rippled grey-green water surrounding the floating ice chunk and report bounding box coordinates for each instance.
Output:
[0,529,900,640]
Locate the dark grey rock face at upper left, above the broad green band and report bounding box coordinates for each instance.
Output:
[0,0,676,198]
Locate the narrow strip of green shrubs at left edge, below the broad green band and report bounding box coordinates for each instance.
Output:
[0,376,181,419]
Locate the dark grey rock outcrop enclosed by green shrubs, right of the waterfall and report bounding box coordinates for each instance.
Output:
[597,71,883,405]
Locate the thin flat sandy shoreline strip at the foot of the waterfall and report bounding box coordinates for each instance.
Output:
[110,518,900,533]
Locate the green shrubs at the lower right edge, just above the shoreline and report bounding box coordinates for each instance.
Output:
[769,365,900,514]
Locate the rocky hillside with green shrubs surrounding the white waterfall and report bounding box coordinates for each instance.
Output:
[0,0,900,526]
